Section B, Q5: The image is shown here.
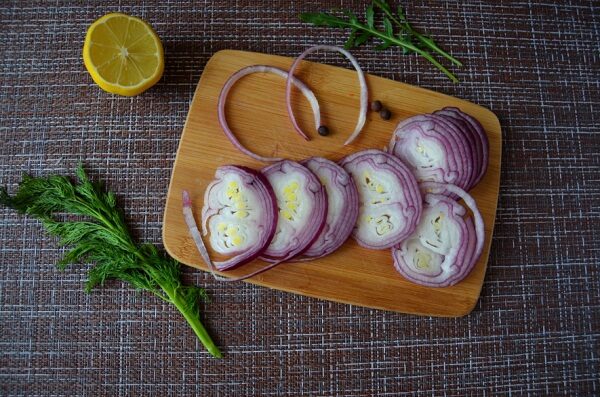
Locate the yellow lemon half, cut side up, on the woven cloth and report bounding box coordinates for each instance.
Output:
[83,13,165,96]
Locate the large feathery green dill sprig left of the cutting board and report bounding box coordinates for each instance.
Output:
[0,165,221,357]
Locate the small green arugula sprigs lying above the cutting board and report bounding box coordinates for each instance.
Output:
[300,0,462,83]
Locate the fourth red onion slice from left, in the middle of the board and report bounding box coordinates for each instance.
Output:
[340,149,422,249]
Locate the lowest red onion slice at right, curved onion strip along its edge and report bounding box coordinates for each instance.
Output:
[392,182,485,287]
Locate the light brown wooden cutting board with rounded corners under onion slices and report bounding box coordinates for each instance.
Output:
[163,50,502,316]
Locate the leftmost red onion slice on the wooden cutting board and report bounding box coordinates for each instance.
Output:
[202,165,277,270]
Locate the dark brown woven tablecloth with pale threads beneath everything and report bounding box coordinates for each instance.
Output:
[0,0,600,396]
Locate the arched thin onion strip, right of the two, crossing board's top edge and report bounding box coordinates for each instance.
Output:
[285,45,369,145]
